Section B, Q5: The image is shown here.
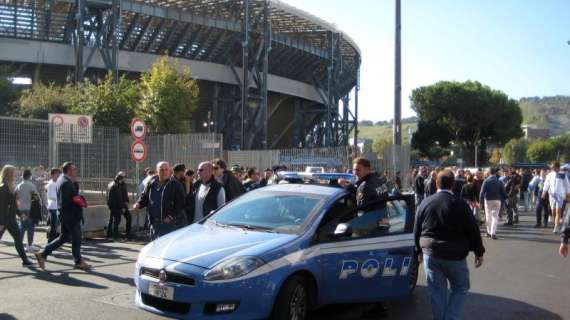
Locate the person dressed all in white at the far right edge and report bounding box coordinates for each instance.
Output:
[542,162,570,233]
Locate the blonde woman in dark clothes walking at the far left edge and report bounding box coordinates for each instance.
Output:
[0,165,33,267]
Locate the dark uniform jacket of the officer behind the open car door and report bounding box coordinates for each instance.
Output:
[347,172,388,212]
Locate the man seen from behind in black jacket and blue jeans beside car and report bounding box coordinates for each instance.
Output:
[414,170,485,320]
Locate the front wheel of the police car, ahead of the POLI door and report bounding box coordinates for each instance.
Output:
[269,276,311,320]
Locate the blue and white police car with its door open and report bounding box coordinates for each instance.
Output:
[134,176,418,320]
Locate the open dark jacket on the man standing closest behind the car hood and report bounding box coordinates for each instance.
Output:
[137,176,187,226]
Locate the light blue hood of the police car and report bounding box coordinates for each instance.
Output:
[146,224,298,269]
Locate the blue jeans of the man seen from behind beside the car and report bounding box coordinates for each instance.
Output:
[424,254,469,320]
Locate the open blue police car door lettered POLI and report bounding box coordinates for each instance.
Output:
[314,195,415,304]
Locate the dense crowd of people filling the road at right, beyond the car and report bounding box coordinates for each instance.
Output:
[410,162,570,239]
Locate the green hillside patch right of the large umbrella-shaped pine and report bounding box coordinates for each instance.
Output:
[519,96,570,135]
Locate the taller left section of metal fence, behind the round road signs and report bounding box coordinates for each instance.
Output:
[0,117,223,205]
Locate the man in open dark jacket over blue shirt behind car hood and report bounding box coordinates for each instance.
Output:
[134,161,188,240]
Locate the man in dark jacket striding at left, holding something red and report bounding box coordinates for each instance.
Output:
[35,162,91,270]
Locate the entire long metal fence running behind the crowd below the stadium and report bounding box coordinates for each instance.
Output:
[0,117,410,205]
